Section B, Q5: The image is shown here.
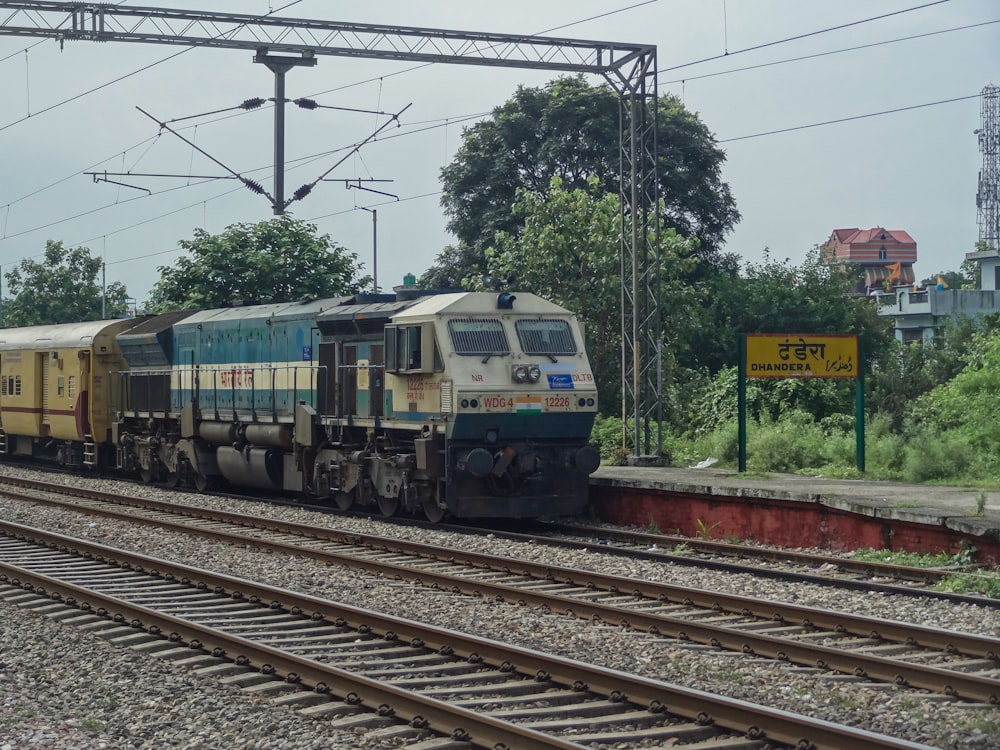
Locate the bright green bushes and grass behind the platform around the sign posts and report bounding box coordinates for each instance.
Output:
[593,316,1000,487]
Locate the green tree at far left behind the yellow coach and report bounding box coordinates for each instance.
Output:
[3,240,128,327]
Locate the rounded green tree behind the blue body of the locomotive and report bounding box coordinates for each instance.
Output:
[150,216,371,312]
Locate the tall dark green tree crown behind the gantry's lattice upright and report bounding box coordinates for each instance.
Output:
[421,76,740,287]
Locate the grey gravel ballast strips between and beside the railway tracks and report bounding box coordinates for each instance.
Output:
[0,467,1000,750]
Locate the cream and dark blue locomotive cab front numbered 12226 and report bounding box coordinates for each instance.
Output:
[385,293,600,518]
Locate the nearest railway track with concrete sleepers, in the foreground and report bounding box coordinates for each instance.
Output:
[0,523,944,750]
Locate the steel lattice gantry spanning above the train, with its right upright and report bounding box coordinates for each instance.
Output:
[0,0,663,455]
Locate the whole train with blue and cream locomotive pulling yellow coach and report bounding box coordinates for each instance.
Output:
[0,287,600,522]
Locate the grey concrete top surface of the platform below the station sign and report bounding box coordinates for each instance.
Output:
[590,466,1000,539]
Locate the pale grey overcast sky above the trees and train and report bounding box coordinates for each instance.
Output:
[0,0,1000,303]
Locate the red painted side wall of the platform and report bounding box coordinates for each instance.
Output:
[590,485,1000,564]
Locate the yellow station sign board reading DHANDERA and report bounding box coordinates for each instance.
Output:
[746,333,861,378]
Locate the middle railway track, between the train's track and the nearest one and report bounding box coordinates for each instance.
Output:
[3,476,1000,704]
